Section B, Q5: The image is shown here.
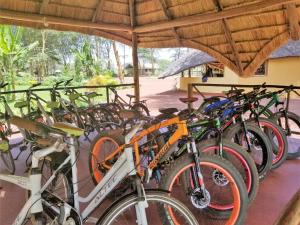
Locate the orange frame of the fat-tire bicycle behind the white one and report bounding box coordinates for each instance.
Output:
[101,117,188,176]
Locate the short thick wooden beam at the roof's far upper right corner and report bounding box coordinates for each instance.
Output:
[285,4,300,41]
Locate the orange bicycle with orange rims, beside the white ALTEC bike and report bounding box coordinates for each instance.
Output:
[89,117,248,224]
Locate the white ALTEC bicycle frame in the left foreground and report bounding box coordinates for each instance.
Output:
[0,135,147,225]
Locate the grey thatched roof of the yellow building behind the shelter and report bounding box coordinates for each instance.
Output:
[159,41,300,78]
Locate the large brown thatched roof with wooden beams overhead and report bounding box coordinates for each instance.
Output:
[0,0,300,75]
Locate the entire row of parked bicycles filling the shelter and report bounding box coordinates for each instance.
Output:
[0,81,300,225]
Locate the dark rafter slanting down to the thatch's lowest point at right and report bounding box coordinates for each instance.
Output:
[214,0,243,75]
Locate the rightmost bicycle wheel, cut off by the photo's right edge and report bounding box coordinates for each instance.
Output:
[274,112,300,159]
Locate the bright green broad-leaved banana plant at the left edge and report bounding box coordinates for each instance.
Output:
[0,25,38,100]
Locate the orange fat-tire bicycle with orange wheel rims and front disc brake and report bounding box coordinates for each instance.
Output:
[89,117,248,224]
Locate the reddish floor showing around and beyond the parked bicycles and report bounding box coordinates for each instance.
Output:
[0,88,300,225]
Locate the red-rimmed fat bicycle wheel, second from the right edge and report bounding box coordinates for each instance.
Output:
[249,118,289,169]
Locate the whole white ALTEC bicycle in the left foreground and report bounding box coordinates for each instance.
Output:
[0,117,198,225]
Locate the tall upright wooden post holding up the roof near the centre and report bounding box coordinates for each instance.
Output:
[132,33,140,102]
